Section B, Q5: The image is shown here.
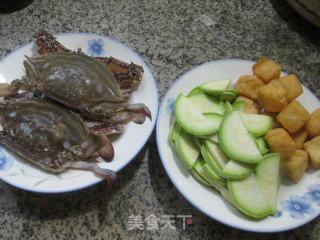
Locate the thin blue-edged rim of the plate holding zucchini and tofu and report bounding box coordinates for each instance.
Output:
[156,58,320,233]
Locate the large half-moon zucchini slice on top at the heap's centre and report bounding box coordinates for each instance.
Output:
[219,110,262,163]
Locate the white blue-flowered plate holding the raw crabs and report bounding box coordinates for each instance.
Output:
[0,33,158,193]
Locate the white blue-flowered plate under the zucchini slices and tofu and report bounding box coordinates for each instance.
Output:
[156,59,320,232]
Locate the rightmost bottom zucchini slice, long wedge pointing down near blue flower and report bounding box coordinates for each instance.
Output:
[256,153,280,214]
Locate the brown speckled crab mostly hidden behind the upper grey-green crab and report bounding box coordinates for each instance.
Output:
[34,30,143,97]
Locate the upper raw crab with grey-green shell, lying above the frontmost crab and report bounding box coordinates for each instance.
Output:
[0,52,151,123]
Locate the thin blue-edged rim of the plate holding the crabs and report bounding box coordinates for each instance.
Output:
[0,32,159,194]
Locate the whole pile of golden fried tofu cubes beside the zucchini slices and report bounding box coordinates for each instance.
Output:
[235,57,320,183]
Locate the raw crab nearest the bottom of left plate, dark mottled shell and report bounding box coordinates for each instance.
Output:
[0,98,115,178]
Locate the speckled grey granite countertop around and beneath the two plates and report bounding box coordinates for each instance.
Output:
[0,0,320,240]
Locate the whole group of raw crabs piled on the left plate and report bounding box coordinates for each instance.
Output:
[0,30,151,178]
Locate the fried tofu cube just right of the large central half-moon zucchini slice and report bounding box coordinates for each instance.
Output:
[264,128,297,159]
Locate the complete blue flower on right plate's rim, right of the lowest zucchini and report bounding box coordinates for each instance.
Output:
[280,195,315,219]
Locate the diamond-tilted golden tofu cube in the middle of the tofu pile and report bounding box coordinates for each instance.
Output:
[277,100,310,133]
